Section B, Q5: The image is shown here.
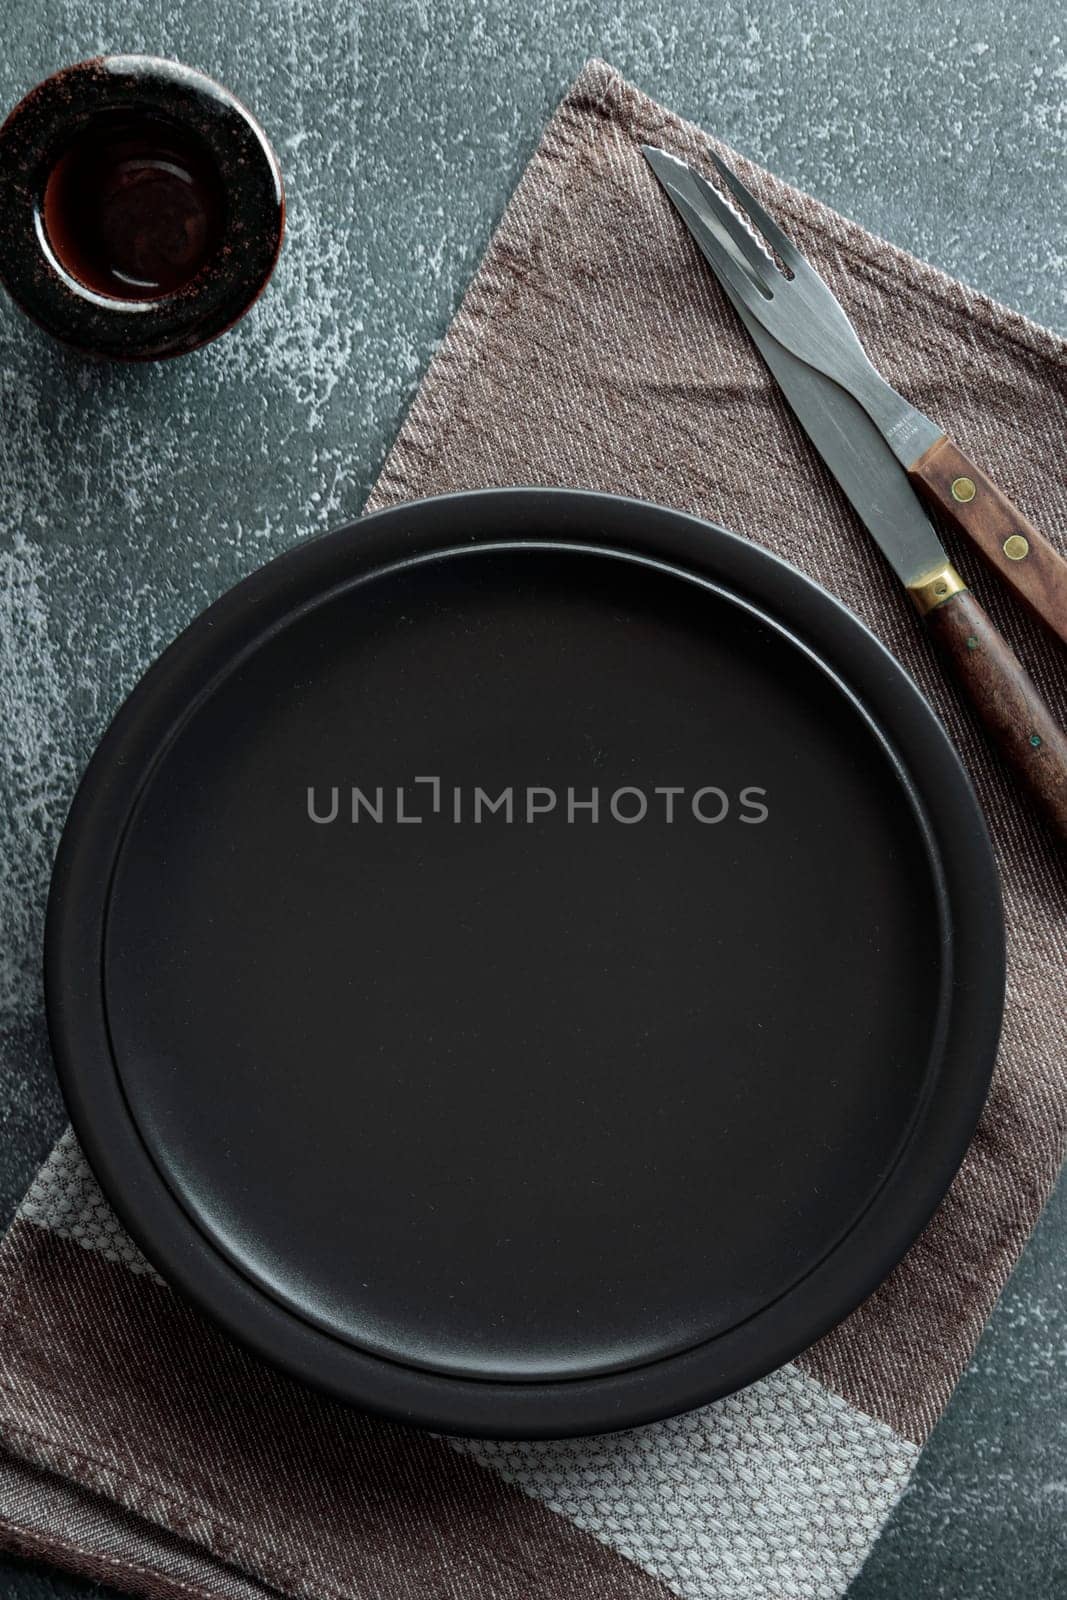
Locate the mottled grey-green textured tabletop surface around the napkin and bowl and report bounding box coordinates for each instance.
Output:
[0,0,1067,1600]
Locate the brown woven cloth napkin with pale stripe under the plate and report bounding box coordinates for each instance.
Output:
[0,62,1067,1600]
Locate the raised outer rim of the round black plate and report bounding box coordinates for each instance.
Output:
[45,488,1005,1438]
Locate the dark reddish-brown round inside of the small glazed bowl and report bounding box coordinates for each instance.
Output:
[43,114,224,301]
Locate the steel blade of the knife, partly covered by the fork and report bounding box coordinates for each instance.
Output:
[643,146,947,586]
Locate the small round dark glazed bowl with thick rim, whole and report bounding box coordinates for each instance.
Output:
[0,56,285,362]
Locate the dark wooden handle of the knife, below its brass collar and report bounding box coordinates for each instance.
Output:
[912,585,1067,840]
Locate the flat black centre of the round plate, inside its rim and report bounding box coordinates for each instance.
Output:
[106,544,939,1381]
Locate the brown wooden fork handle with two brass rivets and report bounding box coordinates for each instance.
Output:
[907,438,1067,643]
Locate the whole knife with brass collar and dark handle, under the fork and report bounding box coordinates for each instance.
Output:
[641,146,1067,840]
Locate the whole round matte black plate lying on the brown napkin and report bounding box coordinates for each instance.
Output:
[46,490,1003,1435]
